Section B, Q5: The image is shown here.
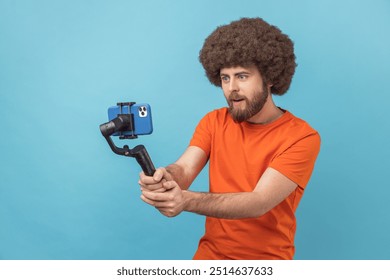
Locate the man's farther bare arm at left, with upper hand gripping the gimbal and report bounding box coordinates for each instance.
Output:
[138,146,208,192]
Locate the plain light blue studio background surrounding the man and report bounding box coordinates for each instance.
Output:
[0,0,390,259]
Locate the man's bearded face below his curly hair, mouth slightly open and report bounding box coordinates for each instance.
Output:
[220,66,268,122]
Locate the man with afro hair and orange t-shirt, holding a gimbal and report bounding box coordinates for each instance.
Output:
[139,18,320,259]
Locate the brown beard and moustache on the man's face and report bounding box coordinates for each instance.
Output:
[227,85,268,123]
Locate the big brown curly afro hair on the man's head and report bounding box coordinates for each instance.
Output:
[199,18,297,95]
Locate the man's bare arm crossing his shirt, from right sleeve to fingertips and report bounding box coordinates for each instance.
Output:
[141,168,297,219]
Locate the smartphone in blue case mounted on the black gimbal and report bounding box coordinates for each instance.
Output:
[108,103,153,136]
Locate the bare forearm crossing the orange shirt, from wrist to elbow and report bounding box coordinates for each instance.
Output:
[183,191,267,219]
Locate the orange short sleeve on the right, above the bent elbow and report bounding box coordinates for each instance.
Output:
[269,132,321,188]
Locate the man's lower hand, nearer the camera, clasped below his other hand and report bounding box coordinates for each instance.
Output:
[141,181,185,217]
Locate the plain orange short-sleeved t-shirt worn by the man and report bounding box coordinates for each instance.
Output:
[190,108,320,259]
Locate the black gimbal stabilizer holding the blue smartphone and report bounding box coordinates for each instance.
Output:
[100,102,155,176]
